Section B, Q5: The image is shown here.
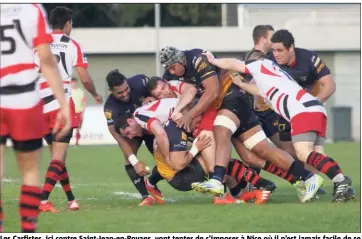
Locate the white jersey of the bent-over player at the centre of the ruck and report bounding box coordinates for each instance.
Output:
[133,98,179,131]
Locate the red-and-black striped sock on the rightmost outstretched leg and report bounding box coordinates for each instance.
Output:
[307,151,344,182]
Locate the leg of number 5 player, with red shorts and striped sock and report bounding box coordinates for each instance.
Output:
[9,102,43,232]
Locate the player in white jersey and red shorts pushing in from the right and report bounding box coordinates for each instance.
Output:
[205,52,355,202]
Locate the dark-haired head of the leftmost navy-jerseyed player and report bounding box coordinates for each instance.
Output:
[106,69,131,102]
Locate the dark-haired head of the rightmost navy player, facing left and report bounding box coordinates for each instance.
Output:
[271,29,294,65]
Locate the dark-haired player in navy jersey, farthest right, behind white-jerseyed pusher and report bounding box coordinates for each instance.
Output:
[271,29,336,156]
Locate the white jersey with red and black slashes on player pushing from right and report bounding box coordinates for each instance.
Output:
[245,59,327,121]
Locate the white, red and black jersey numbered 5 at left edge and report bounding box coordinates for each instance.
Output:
[0,4,53,109]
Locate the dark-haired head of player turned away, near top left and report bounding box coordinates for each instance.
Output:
[49,7,73,36]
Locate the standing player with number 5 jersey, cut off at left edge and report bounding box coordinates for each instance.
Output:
[0,4,70,233]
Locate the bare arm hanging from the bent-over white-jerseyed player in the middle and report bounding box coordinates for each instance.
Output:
[147,119,170,163]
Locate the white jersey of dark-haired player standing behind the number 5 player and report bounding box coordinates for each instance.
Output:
[35,32,88,113]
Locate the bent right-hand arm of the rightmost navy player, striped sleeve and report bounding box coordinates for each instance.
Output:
[313,56,336,103]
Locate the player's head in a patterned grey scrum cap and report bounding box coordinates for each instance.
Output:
[160,46,186,77]
